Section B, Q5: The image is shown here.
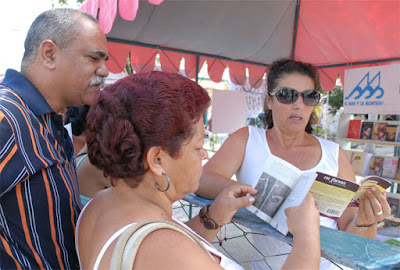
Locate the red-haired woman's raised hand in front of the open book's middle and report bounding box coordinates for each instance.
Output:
[285,193,319,236]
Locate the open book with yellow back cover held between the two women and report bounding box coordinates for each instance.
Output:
[247,156,391,235]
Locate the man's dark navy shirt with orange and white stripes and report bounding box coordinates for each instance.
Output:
[0,70,81,269]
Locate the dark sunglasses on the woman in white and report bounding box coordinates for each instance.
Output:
[268,87,321,106]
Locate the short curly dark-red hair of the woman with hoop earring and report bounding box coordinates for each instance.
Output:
[86,71,210,187]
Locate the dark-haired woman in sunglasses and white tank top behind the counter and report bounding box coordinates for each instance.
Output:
[196,59,390,269]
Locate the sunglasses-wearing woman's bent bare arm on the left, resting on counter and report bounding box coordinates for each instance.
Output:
[195,127,249,199]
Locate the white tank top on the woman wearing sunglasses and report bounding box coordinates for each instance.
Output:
[236,126,339,270]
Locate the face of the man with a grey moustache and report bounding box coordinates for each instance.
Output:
[56,19,108,109]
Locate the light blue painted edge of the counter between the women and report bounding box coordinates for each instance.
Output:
[184,194,400,269]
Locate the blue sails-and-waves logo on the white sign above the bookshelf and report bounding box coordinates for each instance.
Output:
[345,71,385,100]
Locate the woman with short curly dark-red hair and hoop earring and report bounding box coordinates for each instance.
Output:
[76,71,320,270]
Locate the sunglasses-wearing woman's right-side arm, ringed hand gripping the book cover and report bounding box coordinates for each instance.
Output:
[338,148,390,239]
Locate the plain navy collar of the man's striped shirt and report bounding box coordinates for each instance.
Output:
[1,69,54,116]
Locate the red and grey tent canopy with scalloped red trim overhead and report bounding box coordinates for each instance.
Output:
[82,0,400,90]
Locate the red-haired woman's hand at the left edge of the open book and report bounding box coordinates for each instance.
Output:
[209,184,257,226]
